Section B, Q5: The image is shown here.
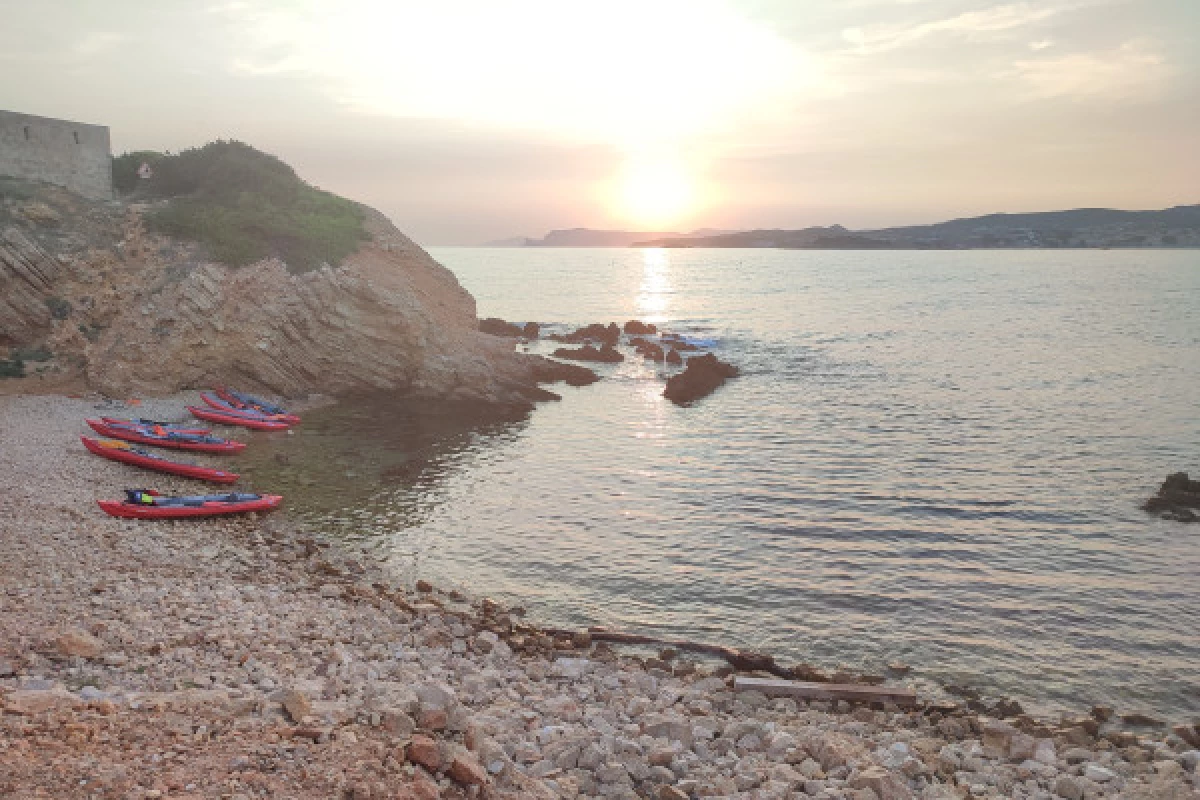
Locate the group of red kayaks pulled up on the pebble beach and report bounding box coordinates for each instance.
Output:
[80,387,300,519]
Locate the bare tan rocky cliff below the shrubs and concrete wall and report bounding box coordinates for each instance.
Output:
[0,181,553,404]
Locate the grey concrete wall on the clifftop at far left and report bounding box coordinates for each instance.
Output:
[0,110,113,199]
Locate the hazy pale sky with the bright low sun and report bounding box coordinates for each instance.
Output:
[0,0,1200,245]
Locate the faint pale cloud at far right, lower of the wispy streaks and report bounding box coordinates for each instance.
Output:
[1003,38,1175,98]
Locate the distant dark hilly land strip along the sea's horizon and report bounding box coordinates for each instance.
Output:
[491,205,1200,249]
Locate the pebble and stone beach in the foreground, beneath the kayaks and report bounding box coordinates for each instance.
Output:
[0,397,1200,800]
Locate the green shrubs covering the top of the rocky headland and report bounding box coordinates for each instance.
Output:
[113,140,367,272]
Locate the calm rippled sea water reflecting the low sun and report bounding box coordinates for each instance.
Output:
[236,248,1200,717]
